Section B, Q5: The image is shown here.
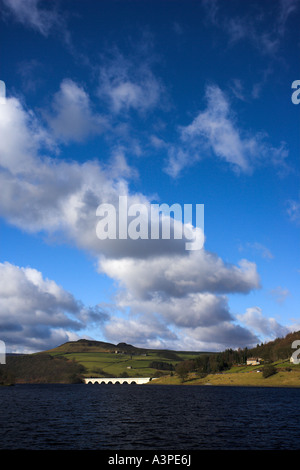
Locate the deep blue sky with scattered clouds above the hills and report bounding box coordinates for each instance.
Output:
[0,0,300,352]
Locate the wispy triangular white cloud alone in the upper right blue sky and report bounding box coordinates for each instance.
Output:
[166,85,288,177]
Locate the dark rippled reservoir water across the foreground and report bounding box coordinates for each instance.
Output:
[0,385,300,451]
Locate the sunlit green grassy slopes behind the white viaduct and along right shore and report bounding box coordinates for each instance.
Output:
[38,340,300,387]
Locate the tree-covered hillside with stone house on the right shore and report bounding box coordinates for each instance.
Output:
[151,331,300,387]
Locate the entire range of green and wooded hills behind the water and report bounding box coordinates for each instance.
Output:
[0,331,300,386]
